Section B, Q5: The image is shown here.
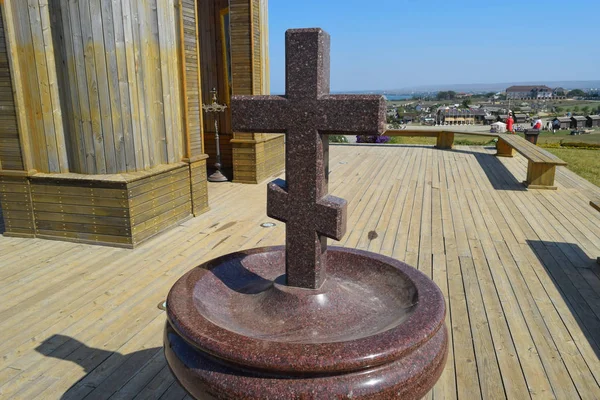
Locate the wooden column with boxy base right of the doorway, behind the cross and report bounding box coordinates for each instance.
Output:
[230,0,285,183]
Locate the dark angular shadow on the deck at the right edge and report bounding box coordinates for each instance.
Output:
[527,240,600,357]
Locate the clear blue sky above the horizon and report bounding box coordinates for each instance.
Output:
[269,0,600,93]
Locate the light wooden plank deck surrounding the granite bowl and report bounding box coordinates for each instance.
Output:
[0,146,600,400]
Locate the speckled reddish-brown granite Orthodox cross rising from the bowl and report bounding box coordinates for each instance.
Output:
[231,29,385,289]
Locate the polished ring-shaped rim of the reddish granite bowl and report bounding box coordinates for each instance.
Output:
[167,246,445,373]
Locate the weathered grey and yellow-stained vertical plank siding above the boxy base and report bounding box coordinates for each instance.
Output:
[0,0,184,174]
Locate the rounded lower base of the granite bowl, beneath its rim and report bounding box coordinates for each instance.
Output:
[164,323,448,400]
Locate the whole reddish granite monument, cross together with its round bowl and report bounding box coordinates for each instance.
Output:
[164,29,448,400]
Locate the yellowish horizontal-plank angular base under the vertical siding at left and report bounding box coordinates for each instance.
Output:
[7,161,195,248]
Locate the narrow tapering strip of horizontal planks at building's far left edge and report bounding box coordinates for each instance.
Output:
[0,8,24,171]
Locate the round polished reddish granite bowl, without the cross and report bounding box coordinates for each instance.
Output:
[164,247,448,399]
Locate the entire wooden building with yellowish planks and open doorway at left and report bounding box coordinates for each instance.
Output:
[0,0,284,247]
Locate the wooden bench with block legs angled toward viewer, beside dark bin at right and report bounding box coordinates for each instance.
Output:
[496,134,567,190]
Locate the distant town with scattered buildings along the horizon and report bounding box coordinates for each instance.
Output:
[387,85,600,129]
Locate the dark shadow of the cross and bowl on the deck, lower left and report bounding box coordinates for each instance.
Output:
[35,335,180,400]
